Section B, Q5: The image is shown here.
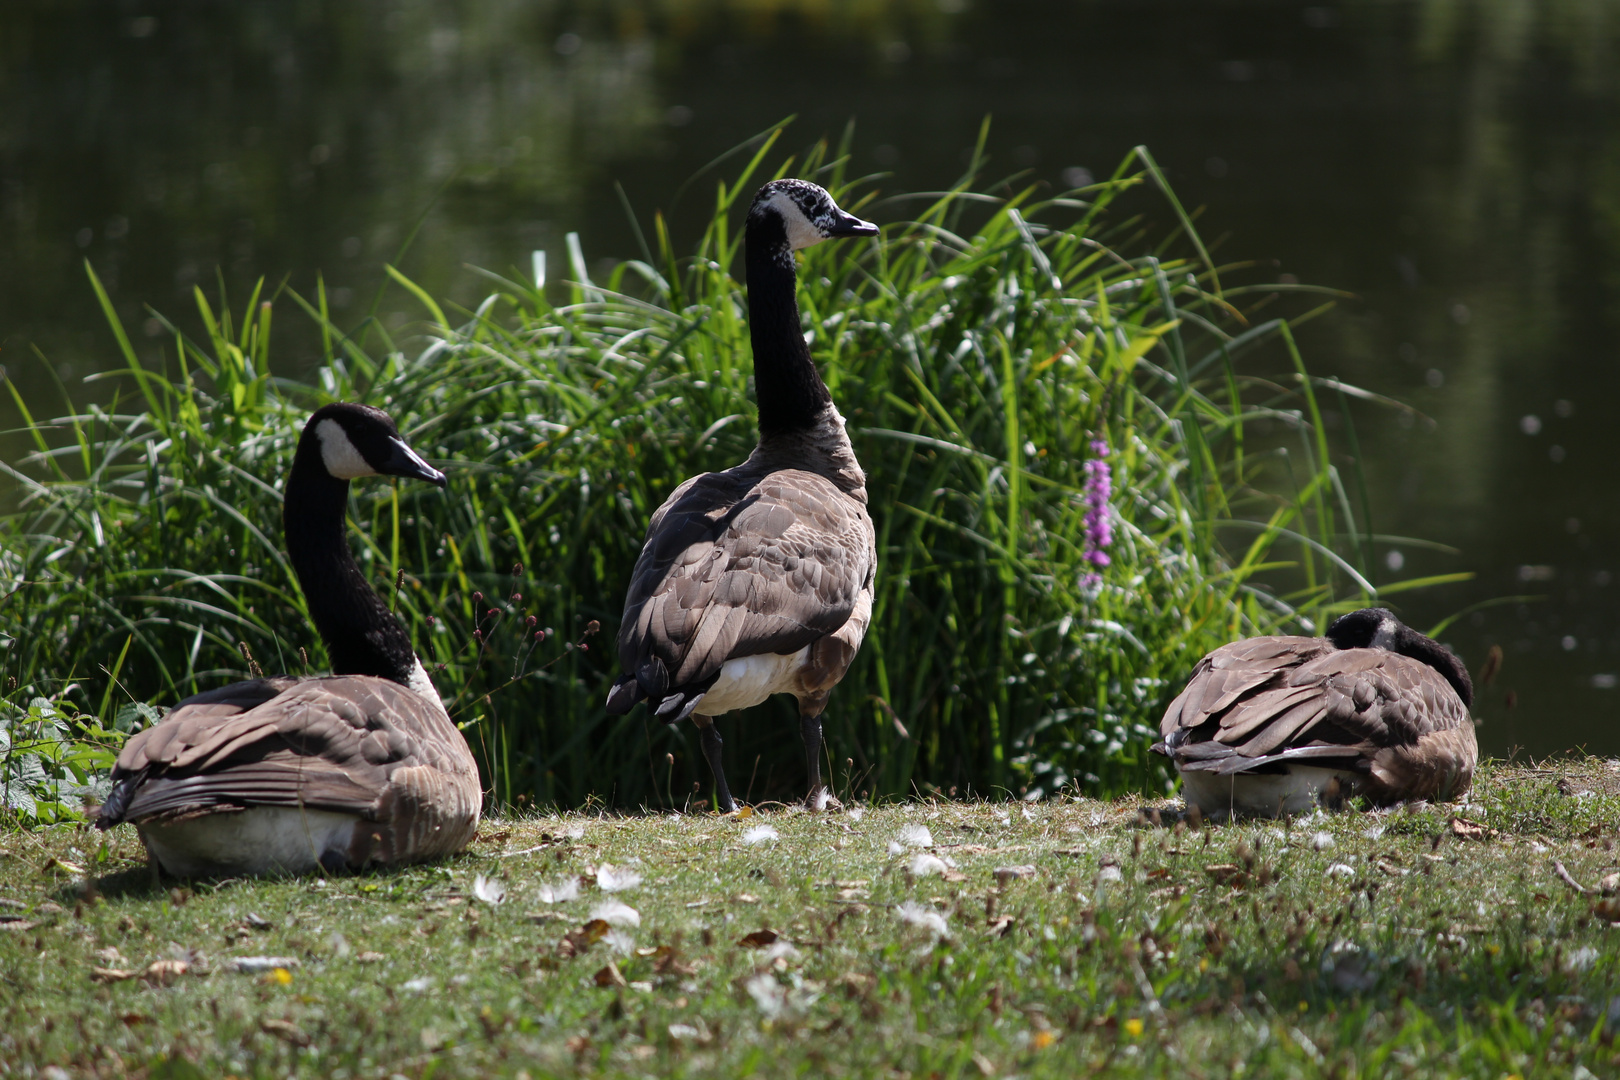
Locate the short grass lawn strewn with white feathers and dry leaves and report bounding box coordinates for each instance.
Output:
[0,759,1620,1080]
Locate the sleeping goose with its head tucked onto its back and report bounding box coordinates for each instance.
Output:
[1153,607,1479,816]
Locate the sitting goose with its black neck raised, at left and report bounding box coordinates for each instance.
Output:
[96,403,483,878]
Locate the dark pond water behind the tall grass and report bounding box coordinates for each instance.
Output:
[0,0,1620,753]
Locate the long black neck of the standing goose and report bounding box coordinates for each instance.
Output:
[745,212,833,439]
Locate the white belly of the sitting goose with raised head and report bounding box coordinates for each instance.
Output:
[138,806,360,878]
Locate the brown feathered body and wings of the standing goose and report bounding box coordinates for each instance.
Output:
[619,466,875,688]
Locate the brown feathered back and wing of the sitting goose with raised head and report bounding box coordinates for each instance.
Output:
[104,675,478,824]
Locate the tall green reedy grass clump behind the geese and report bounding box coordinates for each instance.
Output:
[0,131,1464,806]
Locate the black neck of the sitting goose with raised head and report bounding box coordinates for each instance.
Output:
[282,436,416,683]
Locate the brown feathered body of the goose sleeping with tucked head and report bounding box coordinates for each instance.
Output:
[1160,638,1479,801]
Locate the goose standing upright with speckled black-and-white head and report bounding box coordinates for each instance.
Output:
[608,180,878,813]
